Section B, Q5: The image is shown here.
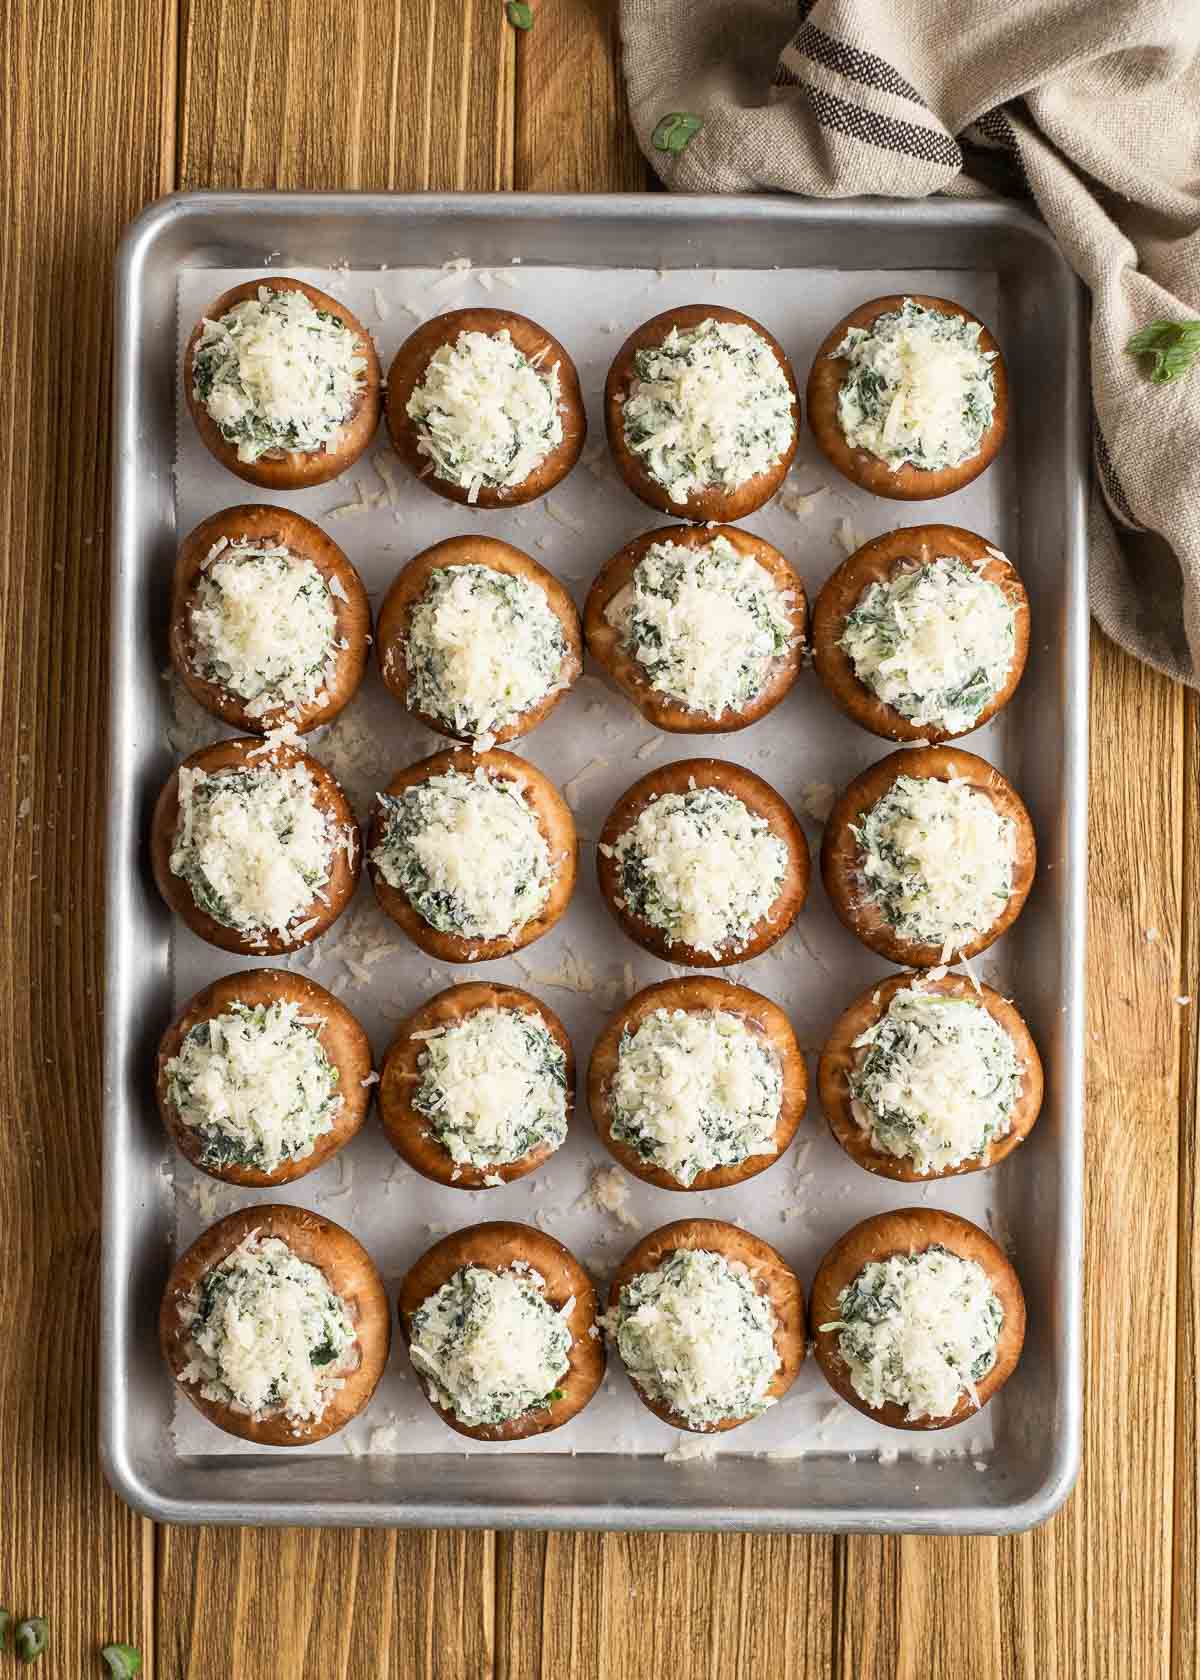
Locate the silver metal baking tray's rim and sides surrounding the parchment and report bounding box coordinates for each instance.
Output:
[101,193,1087,1532]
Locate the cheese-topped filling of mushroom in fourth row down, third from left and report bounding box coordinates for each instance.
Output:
[610,1010,783,1184]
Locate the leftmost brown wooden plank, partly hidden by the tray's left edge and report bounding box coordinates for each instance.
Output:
[0,0,175,1680]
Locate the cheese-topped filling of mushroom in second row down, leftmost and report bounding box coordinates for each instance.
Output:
[188,538,338,717]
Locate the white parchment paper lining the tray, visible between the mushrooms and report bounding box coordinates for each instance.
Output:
[163,262,1015,1487]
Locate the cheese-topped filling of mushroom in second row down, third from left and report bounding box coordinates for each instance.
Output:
[605,536,797,717]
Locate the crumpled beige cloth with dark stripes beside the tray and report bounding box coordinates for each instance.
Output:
[620,0,1200,685]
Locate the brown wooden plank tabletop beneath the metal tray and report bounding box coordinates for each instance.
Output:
[0,0,1200,1680]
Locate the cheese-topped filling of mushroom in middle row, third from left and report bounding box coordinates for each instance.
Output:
[600,783,788,956]
